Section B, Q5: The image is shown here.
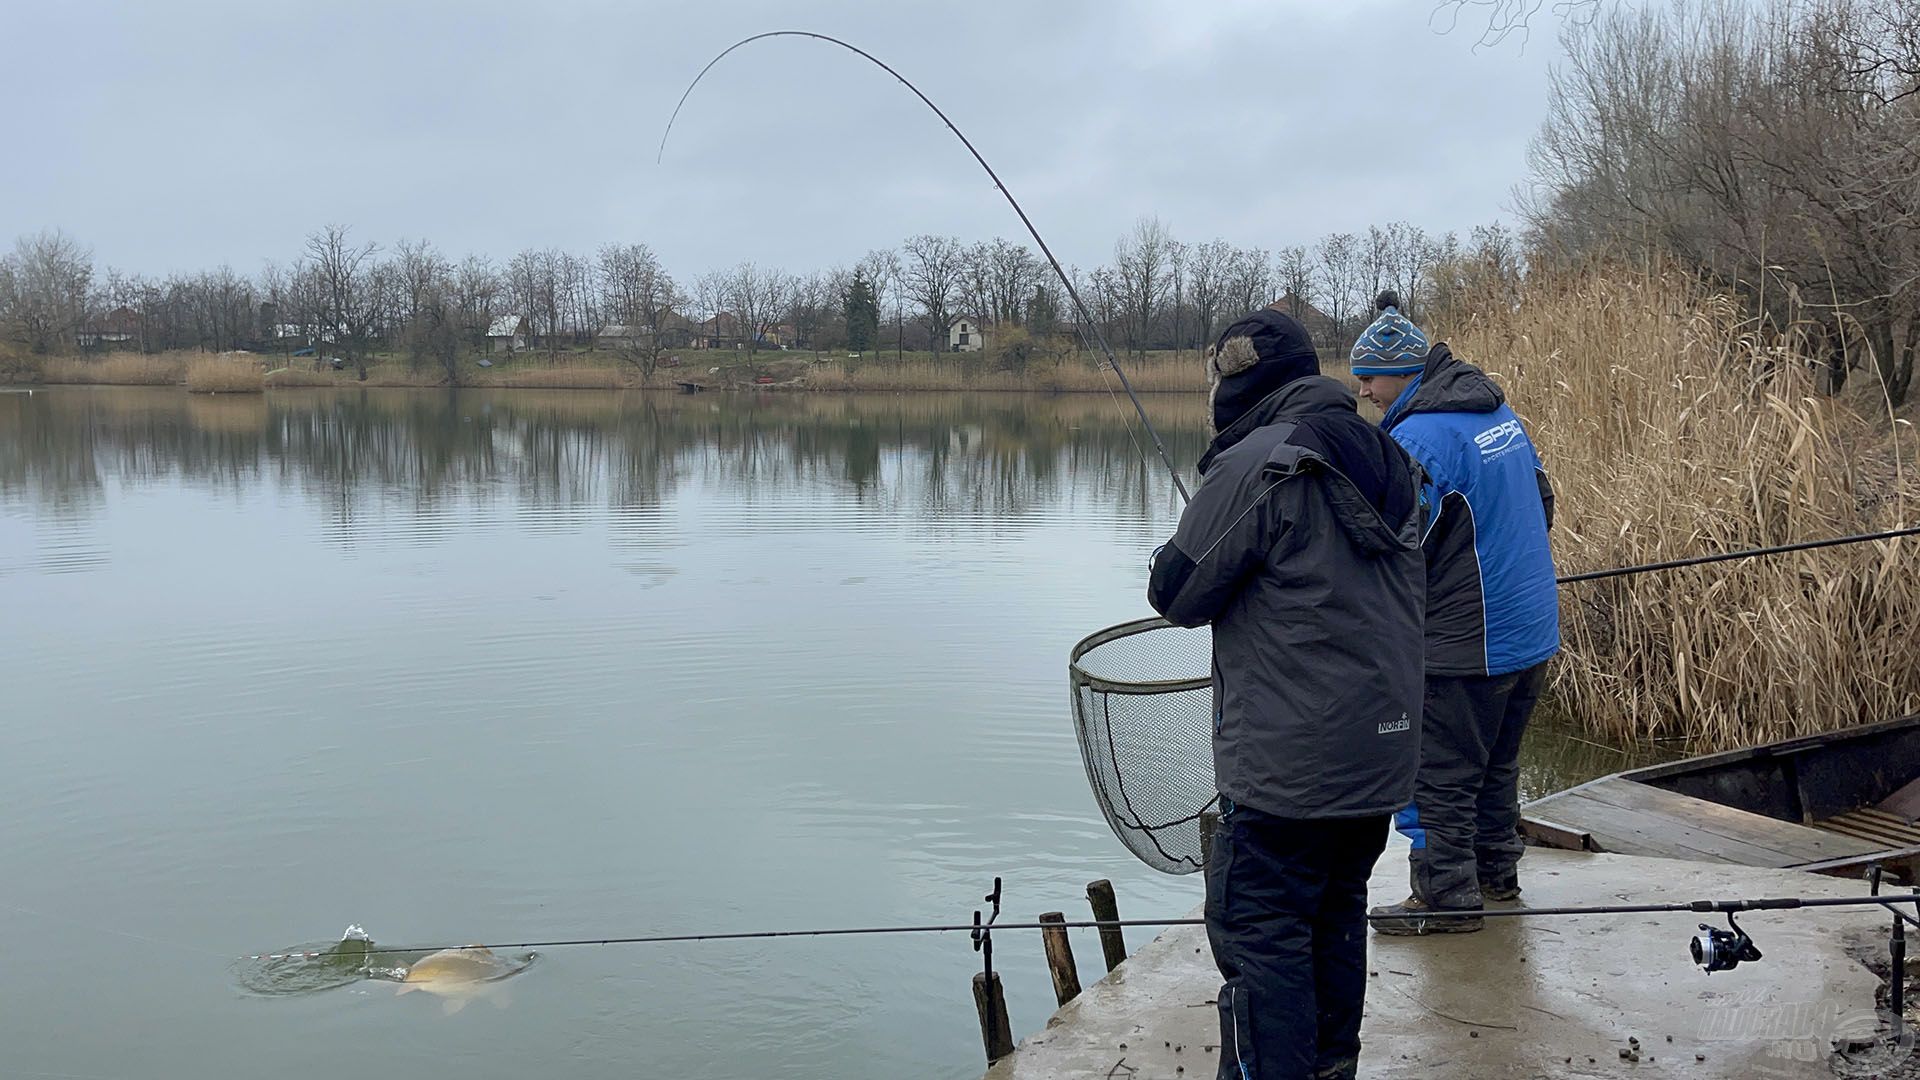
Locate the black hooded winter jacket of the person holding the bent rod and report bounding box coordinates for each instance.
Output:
[1148,375,1427,819]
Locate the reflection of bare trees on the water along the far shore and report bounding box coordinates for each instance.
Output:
[0,388,1204,561]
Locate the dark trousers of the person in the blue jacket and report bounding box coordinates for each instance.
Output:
[1396,663,1548,907]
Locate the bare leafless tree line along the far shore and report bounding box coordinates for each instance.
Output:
[0,217,1521,377]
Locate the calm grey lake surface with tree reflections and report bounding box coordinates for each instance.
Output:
[0,388,1622,1080]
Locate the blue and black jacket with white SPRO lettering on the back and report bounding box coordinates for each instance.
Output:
[1380,344,1559,676]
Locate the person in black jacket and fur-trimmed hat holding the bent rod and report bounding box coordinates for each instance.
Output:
[1148,309,1427,1080]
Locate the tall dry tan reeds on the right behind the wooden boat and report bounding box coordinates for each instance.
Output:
[1442,275,1920,748]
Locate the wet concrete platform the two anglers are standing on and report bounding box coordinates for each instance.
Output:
[987,846,1887,1080]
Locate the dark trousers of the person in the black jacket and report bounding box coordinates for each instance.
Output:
[1206,807,1390,1080]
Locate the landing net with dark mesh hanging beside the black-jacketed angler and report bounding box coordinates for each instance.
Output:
[1069,619,1219,874]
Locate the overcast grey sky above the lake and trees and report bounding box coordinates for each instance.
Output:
[0,0,1561,277]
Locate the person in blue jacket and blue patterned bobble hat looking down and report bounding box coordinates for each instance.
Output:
[1354,292,1559,934]
